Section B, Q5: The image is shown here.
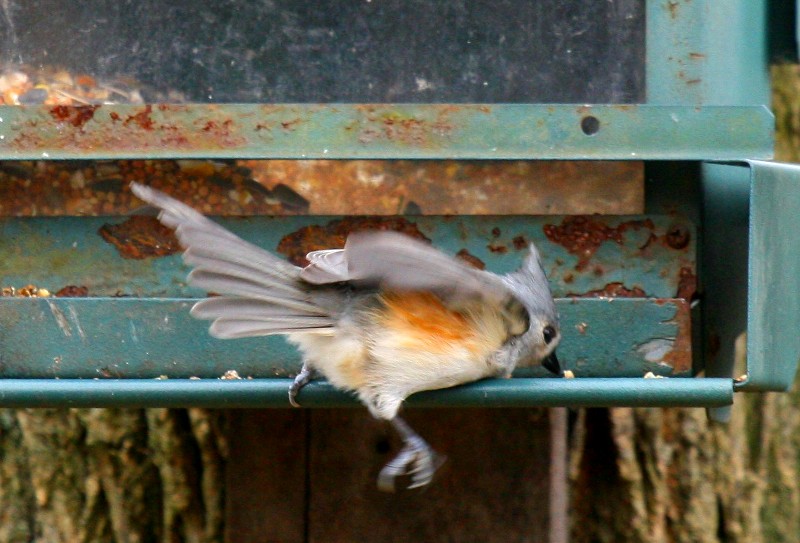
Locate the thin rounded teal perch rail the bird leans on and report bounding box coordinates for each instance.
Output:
[0,378,733,408]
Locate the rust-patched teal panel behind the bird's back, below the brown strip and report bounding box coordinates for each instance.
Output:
[0,215,696,299]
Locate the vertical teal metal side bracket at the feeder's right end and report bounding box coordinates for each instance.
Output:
[702,161,800,408]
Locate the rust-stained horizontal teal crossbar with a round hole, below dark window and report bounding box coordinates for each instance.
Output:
[0,104,774,160]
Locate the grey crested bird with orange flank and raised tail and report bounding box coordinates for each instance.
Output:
[131,182,562,491]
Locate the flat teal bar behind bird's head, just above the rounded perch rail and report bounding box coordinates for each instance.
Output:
[0,298,691,380]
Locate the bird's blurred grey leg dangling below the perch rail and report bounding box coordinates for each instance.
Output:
[378,417,444,492]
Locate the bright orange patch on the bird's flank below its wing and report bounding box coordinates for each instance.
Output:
[382,292,482,351]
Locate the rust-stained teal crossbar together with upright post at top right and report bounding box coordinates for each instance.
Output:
[0,0,773,160]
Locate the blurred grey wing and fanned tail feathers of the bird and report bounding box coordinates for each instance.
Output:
[131,183,546,338]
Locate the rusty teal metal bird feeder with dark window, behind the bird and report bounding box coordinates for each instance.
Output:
[0,0,800,428]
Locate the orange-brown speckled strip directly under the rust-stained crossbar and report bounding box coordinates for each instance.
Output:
[0,160,644,216]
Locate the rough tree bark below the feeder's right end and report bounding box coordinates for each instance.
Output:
[572,384,800,543]
